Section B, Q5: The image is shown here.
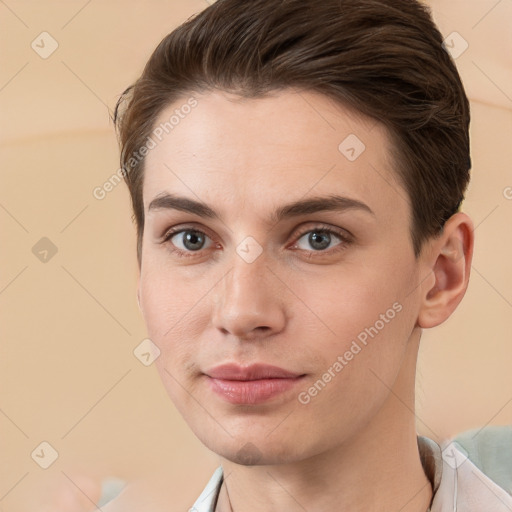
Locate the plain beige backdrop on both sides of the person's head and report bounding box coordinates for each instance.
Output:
[0,0,512,512]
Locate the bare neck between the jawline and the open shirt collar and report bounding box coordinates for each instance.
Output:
[215,329,432,512]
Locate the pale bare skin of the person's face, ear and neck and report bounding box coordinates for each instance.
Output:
[131,89,474,512]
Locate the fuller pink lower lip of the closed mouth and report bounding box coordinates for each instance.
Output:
[208,376,303,405]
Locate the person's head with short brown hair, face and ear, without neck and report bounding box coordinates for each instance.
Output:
[114,0,473,463]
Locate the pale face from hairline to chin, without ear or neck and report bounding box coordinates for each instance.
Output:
[139,91,426,464]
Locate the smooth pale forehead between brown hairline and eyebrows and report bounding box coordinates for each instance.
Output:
[143,90,408,222]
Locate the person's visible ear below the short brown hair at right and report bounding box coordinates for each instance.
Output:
[418,212,474,329]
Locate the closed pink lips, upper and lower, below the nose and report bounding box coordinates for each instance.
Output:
[205,363,305,405]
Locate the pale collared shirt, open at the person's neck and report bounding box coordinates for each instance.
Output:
[189,426,512,512]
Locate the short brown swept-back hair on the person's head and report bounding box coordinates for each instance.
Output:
[113,0,471,265]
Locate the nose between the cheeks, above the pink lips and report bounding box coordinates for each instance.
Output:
[212,254,286,340]
